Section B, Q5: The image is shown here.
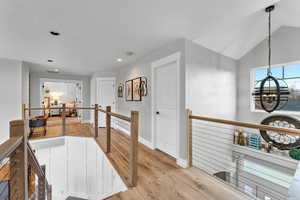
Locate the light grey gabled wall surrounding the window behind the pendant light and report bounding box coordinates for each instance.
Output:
[237,27,300,123]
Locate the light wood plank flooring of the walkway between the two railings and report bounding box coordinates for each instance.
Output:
[97,129,251,200]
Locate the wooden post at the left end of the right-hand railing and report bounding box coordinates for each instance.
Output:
[186,109,193,167]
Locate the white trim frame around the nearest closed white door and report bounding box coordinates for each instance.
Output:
[151,52,181,160]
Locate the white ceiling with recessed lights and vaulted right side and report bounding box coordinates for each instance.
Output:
[0,0,300,75]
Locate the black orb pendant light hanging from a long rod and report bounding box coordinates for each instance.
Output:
[252,5,290,113]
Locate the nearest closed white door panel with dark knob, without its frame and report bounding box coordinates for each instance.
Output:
[153,61,178,157]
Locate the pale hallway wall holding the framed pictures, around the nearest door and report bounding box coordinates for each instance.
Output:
[91,39,186,158]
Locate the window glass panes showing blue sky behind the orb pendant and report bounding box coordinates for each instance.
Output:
[251,64,300,112]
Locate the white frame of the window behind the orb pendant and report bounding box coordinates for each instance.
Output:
[249,61,300,116]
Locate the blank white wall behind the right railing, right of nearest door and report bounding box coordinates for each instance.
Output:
[186,41,237,174]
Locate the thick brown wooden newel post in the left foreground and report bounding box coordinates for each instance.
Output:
[10,120,28,200]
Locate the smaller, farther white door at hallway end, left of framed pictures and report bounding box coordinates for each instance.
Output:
[97,78,115,127]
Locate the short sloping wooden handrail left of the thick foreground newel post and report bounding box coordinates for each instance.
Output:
[0,136,23,161]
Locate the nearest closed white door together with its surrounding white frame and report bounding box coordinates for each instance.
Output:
[152,53,180,158]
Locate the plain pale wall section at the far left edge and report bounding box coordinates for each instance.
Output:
[0,59,23,143]
